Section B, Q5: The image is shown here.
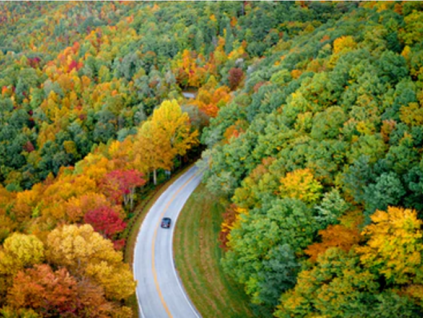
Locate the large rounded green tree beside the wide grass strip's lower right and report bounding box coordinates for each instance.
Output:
[222,198,318,304]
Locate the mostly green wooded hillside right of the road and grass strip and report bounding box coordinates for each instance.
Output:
[202,2,423,317]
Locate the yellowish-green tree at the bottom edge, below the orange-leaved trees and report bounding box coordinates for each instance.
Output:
[275,248,420,318]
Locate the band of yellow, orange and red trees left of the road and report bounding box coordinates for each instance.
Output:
[0,95,198,317]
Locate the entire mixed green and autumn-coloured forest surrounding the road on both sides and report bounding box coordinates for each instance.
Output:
[0,1,423,318]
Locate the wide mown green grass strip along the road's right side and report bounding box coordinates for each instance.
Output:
[173,184,255,318]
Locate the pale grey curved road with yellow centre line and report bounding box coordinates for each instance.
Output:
[134,167,201,318]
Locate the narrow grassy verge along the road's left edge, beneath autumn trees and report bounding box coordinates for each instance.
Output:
[124,163,193,318]
